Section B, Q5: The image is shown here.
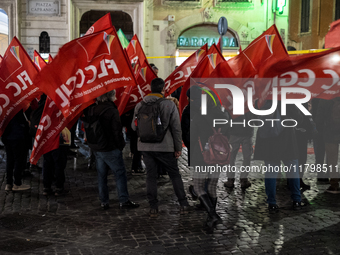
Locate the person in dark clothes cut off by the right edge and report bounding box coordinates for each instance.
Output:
[315,97,340,194]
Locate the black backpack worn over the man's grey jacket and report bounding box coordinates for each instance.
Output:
[136,98,167,143]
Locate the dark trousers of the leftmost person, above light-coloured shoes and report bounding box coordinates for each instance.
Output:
[4,140,27,186]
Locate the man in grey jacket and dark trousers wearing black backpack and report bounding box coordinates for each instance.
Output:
[131,78,190,217]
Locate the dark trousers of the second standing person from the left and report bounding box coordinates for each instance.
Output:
[43,146,68,189]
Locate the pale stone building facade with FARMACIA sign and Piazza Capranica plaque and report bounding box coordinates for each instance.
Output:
[0,0,292,78]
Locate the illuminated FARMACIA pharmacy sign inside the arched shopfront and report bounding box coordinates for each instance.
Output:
[177,36,238,47]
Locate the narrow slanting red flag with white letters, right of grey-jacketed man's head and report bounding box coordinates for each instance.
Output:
[164,44,208,97]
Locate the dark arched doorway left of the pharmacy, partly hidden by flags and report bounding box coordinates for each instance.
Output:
[79,11,134,40]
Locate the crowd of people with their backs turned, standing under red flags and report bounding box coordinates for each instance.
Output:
[2,78,340,231]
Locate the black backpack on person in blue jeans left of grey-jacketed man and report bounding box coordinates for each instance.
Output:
[82,106,110,151]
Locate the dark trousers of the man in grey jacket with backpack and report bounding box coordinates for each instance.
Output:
[142,151,188,208]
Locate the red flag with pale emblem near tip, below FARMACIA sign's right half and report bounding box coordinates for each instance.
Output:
[179,44,225,114]
